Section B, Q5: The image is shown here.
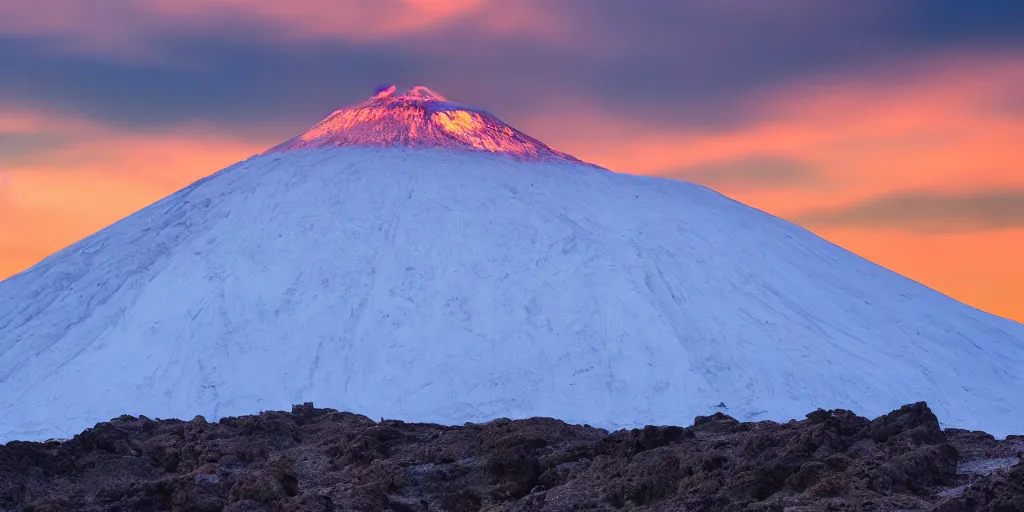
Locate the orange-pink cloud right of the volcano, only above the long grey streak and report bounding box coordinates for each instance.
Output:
[522,55,1024,215]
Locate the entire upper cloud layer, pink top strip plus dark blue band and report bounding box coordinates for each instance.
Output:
[0,0,1024,137]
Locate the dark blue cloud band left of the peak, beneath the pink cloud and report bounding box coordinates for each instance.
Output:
[0,36,422,138]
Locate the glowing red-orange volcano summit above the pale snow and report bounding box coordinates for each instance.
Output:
[267,85,582,163]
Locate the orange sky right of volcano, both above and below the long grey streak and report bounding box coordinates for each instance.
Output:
[512,52,1024,321]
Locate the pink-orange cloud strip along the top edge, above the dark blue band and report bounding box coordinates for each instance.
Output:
[0,0,561,54]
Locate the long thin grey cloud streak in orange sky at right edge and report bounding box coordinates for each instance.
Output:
[797,188,1024,232]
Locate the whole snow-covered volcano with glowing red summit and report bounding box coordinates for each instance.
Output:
[0,86,1024,440]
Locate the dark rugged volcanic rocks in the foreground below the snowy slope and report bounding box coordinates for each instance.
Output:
[0,403,1024,512]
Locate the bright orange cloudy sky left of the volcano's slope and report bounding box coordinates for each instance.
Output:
[0,108,263,279]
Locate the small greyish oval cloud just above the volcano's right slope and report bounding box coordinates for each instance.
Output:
[662,154,818,190]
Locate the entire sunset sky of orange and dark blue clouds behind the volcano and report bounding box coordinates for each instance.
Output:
[0,0,1024,322]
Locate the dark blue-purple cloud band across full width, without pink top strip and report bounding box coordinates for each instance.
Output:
[0,0,1024,137]
